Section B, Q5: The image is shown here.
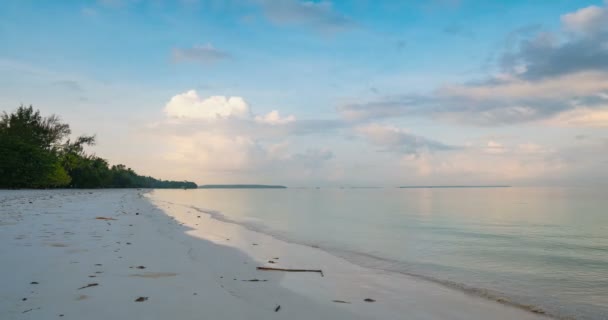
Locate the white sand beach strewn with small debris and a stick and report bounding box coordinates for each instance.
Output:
[0,190,547,320]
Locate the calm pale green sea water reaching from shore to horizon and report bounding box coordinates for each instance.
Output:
[154,188,608,319]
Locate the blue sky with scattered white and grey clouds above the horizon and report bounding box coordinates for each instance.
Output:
[0,0,608,186]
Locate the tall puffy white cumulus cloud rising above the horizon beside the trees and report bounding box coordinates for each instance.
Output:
[148,90,333,183]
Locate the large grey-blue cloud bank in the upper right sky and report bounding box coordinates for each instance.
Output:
[338,4,608,126]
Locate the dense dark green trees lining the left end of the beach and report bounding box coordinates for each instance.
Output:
[0,106,196,188]
